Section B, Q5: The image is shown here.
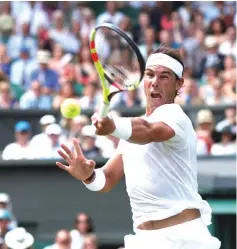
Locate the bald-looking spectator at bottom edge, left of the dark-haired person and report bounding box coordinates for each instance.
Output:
[44,230,73,249]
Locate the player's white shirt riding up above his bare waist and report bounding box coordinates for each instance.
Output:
[118,104,211,230]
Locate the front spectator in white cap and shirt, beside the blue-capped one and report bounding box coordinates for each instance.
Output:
[34,124,65,159]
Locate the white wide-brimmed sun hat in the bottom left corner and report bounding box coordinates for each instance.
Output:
[5,227,34,249]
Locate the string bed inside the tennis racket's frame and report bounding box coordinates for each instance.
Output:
[95,27,141,89]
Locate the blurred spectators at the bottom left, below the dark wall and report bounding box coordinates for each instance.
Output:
[0,193,107,249]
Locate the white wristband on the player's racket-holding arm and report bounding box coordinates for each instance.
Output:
[111,117,132,140]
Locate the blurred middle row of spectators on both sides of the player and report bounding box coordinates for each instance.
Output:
[2,104,236,160]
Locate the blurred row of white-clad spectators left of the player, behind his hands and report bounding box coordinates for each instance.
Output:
[2,112,119,160]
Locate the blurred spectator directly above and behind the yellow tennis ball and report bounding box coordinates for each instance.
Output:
[53,82,79,109]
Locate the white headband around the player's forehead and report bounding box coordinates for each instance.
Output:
[146,53,184,78]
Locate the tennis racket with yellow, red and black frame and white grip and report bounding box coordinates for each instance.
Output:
[90,23,145,118]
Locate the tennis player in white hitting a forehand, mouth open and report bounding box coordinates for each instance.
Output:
[56,46,221,249]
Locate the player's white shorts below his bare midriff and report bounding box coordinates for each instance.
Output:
[124,218,221,249]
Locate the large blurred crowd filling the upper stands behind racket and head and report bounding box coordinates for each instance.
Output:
[0,1,236,110]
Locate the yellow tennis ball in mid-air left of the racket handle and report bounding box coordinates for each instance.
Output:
[60,99,81,118]
